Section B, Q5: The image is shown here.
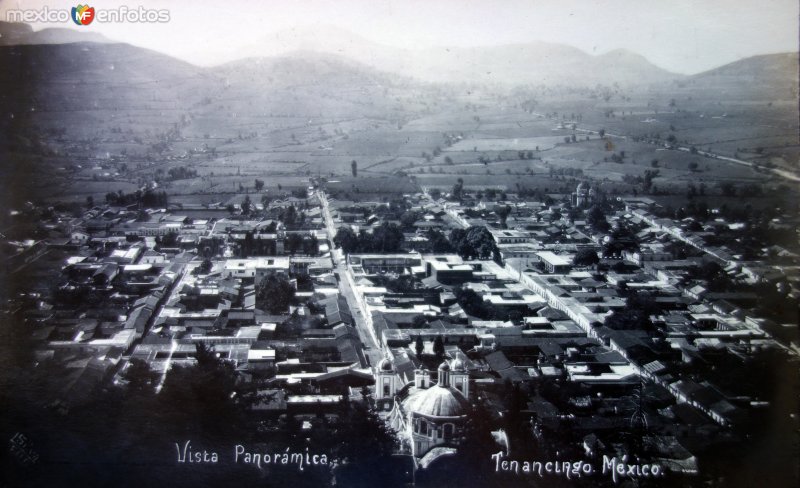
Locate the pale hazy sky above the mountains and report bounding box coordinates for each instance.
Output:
[0,0,798,73]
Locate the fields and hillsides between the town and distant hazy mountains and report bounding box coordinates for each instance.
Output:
[0,42,800,210]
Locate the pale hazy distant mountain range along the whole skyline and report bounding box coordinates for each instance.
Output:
[0,22,797,91]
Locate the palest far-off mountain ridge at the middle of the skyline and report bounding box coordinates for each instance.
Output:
[233,27,681,86]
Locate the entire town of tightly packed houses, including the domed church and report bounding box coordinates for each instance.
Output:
[7,181,797,473]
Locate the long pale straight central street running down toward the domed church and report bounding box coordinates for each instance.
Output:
[317,190,383,365]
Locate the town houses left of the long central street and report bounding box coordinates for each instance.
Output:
[7,194,371,408]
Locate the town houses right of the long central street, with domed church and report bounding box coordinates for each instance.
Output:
[328,186,797,473]
